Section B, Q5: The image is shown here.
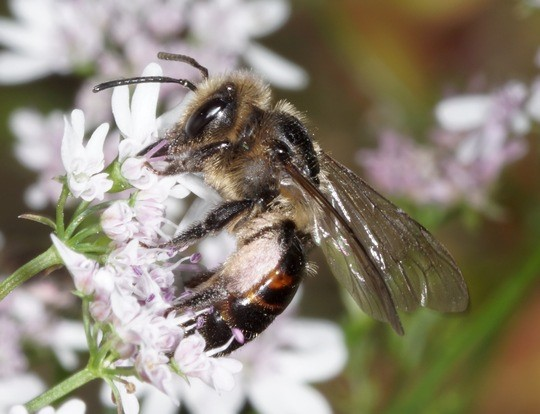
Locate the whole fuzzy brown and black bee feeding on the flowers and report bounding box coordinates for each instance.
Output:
[94,52,469,355]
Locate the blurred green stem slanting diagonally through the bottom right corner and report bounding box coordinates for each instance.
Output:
[385,247,540,413]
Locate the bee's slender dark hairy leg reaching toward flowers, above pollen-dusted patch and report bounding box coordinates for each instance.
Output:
[158,200,256,250]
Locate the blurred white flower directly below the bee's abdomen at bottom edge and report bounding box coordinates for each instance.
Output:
[177,311,347,414]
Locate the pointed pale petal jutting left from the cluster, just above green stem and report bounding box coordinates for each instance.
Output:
[51,234,99,295]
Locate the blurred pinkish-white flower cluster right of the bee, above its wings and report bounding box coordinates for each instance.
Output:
[358,73,540,211]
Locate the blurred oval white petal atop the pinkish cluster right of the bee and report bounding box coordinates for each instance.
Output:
[435,95,492,132]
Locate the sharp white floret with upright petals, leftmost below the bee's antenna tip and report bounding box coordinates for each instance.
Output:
[61,109,113,201]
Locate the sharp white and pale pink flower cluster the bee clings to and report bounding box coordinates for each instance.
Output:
[45,64,246,408]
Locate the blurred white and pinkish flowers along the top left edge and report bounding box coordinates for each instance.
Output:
[0,0,307,90]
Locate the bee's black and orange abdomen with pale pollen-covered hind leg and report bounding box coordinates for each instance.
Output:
[174,220,306,355]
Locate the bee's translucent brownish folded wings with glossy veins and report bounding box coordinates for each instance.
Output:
[288,153,469,334]
